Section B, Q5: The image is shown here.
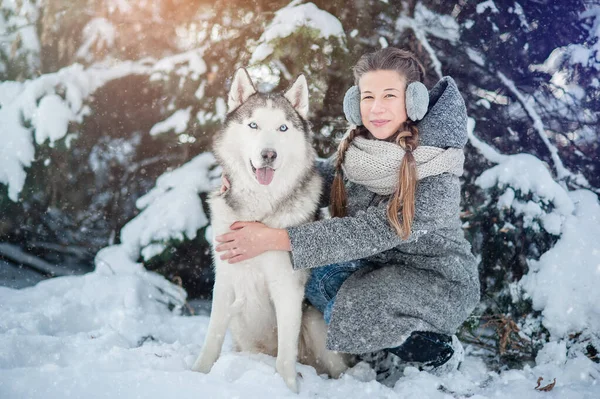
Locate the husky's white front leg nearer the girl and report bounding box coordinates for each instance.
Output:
[269,276,304,393]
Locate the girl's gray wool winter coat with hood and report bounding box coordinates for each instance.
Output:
[287,77,479,353]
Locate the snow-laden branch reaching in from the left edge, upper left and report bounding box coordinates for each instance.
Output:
[0,49,207,202]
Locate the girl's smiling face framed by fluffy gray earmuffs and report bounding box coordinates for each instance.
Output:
[358,70,408,140]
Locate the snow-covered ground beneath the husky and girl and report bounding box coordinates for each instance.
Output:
[0,265,600,399]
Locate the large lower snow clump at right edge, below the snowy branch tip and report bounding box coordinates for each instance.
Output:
[519,190,600,340]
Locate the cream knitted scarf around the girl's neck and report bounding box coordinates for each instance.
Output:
[342,136,465,195]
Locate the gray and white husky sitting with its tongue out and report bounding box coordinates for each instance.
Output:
[192,68,347,392]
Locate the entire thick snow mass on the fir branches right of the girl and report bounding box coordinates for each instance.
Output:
[468,127,600,341]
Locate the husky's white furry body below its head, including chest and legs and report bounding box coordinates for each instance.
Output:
[193,182,348,392]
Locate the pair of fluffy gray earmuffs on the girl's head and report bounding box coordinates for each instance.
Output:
[344,82,429,126]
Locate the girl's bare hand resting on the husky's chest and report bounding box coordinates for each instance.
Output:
[215,222,291,263]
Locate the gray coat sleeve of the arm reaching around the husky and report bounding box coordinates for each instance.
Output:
[287,174,460,270]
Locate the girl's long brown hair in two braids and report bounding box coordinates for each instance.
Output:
[329,47,425,240]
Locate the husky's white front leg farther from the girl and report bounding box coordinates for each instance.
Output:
[192,277,233,374]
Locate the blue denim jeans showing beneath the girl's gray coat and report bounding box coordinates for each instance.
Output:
[305,259,367,324]
